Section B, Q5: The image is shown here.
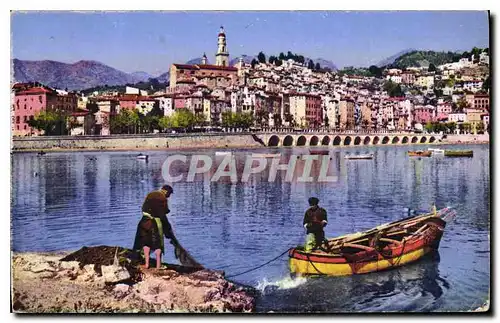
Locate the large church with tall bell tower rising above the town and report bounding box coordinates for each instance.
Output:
[170,27,238,92]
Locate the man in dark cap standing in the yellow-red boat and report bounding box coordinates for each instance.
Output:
[304,197,328,251]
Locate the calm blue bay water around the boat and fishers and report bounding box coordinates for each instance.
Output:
[11,145,490,312]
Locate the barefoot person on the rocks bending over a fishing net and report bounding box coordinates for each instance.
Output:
[134,185,175,268]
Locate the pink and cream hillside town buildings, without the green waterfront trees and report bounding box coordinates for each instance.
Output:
[12,27,490,136]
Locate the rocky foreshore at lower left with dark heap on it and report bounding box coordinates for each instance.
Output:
[11,246,255,313]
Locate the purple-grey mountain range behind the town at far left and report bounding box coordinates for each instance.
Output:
[12,59,144,90]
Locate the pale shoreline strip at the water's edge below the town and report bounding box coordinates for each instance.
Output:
[11,134,490,154]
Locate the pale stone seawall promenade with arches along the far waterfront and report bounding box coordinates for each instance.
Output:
[12,133,489,152]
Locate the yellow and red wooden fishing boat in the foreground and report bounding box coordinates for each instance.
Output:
[288,208,456,276]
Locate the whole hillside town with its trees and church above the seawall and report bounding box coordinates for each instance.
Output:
[11,27,490,136]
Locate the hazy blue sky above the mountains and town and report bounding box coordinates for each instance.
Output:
[11,11,489,74]
